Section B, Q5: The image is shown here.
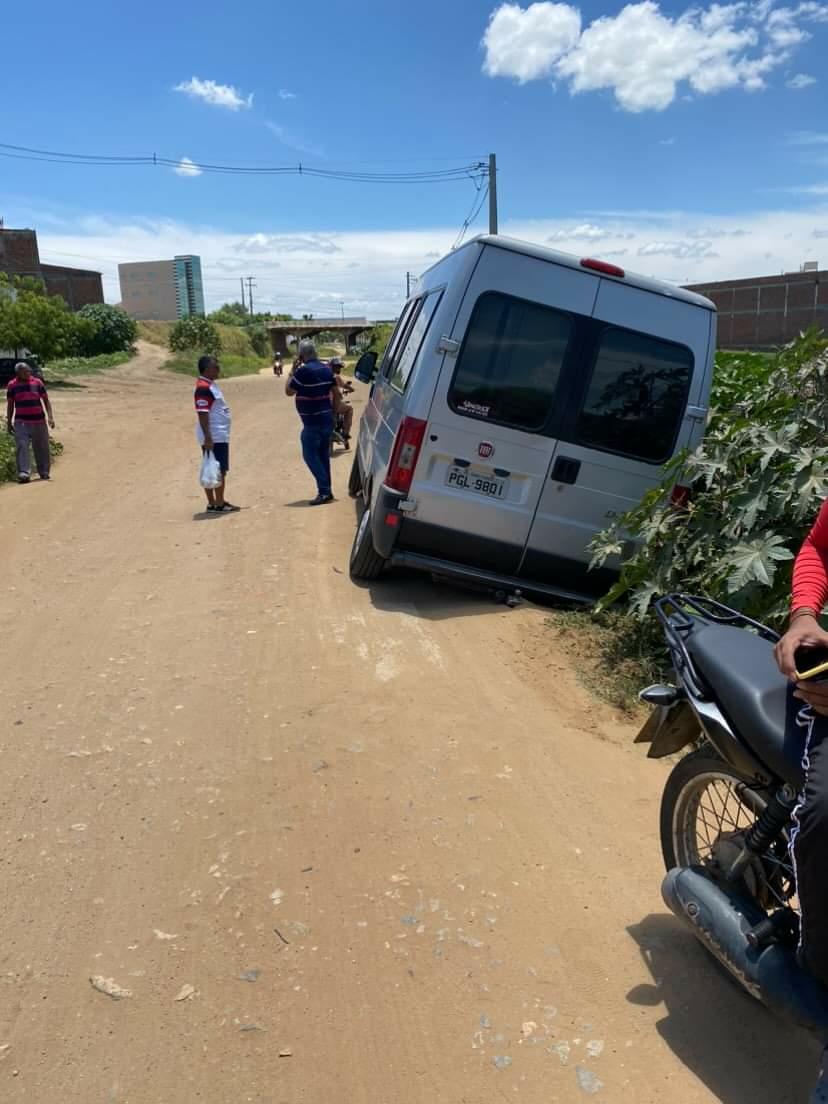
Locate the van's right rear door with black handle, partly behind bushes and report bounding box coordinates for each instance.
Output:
[520,279,713,593]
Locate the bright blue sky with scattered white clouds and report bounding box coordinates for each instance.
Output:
[0,0,828,315]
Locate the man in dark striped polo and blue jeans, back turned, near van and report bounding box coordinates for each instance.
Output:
[285,341,335,506]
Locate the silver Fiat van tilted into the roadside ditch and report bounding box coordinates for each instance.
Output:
[349,228,715,597]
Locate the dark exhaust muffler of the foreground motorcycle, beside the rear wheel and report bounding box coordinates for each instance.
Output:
[661,867,828,1039]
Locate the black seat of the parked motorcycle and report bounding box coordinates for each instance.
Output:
[687,624,805,789]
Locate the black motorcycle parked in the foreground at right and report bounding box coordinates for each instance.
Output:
[636,594,828,1041]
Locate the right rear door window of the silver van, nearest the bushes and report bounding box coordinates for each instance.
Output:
[576,327,693,464]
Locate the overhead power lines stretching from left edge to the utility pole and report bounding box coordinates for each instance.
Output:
[0,142,488,184]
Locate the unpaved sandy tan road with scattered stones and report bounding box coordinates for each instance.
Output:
[0,352,816,1104]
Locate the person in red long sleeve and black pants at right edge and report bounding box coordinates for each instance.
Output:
[776,500,828,1101]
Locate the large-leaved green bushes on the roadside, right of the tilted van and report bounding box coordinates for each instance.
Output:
[565,330,828,704]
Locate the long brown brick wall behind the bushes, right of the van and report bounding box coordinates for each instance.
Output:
[689,269,828,349]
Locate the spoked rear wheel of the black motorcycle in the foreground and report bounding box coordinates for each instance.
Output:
[660,745,794,910]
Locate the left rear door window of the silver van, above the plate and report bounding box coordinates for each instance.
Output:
[448,291,574,429]
